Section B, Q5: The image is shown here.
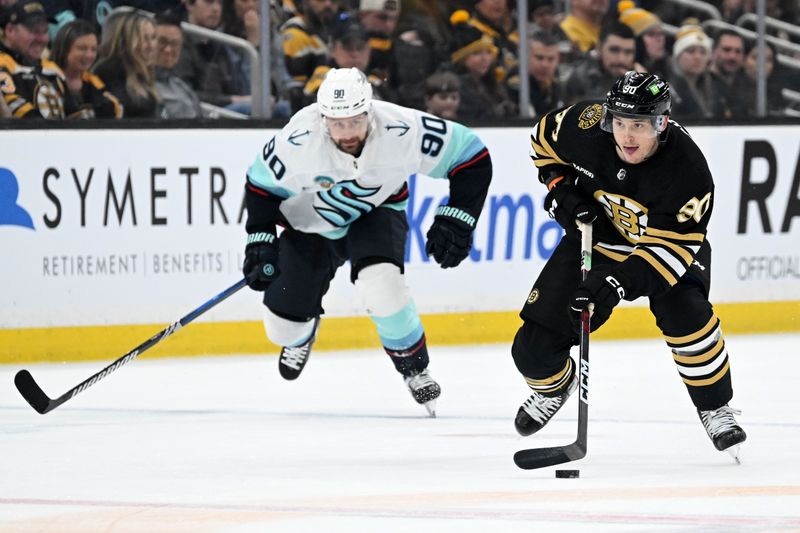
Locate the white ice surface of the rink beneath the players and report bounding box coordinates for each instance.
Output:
[0,334,800,533]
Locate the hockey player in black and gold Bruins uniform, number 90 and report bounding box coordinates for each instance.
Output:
[511,71,746,460]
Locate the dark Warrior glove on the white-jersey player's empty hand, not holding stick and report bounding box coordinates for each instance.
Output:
[425,205,476,268]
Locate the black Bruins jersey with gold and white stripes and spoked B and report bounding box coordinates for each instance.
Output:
[531,100,714,300]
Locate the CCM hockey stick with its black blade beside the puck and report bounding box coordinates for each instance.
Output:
[514,222,592,470]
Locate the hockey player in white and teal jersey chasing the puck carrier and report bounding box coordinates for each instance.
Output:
[243,68,492,416]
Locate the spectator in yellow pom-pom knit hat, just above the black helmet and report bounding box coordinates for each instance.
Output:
[617,0,672,79]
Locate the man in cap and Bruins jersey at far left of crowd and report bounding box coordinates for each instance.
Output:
[0,0,75,119]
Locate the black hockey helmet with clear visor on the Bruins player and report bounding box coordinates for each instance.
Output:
[600,70,672,140]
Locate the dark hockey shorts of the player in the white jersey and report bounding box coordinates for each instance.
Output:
[264,207,408,321]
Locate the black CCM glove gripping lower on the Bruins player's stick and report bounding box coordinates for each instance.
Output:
[569,266,625,333]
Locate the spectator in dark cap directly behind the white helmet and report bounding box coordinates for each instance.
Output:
[303,20,392,105]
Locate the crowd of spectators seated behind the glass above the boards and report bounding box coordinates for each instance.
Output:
[0,0,800,121]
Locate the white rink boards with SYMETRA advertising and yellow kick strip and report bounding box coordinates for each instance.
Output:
[0,126,800,362]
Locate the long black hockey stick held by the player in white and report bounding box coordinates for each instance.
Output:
[14,279,246,414]
